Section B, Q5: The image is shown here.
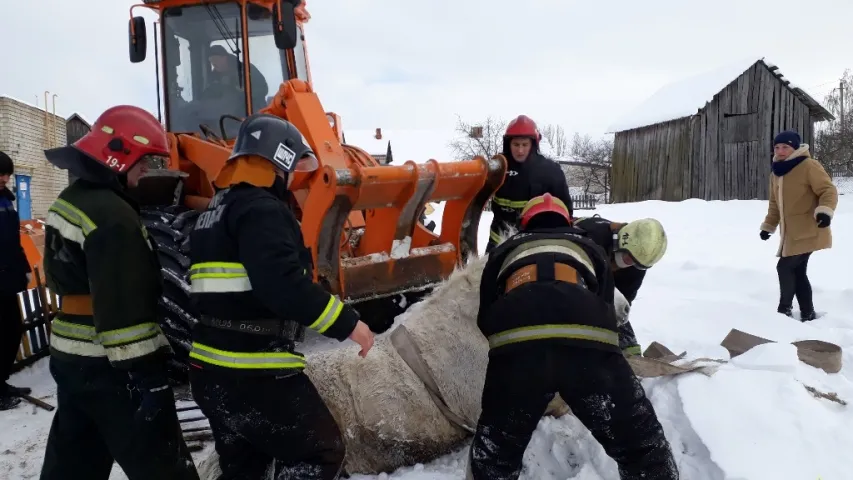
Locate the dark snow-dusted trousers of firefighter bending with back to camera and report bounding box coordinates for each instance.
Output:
[469,345,679,480]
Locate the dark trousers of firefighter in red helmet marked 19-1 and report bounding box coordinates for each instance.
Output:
[40,358,199,480]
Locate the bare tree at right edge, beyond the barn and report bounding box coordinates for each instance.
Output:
[814,70,853,174]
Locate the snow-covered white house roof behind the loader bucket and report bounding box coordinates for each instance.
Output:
[344,128,457,165]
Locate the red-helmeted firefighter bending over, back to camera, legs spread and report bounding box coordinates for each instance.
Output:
[468,193,679,480]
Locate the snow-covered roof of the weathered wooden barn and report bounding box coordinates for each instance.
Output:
[607,57,835,133]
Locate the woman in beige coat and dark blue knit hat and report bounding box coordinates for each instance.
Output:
[761,131,838,322]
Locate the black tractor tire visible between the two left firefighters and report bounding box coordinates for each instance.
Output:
[141,205,201,385]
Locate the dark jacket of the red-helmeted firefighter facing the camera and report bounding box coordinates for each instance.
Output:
[489,152,573,250]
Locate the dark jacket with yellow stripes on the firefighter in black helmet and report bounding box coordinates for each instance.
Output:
[190,183,359,375]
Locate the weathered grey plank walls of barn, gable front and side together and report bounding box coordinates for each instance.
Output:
[612,62,814,202]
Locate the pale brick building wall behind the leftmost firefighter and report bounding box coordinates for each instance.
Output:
[0,96,68,219]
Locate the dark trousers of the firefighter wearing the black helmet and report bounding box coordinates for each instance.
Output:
[190,367,346,480]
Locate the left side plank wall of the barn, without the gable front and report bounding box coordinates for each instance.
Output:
[611,118,691,202]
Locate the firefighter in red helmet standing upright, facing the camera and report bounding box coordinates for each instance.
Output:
[486,115,574,253]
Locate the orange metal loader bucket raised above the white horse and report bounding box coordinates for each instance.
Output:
[300,155,506,332]
